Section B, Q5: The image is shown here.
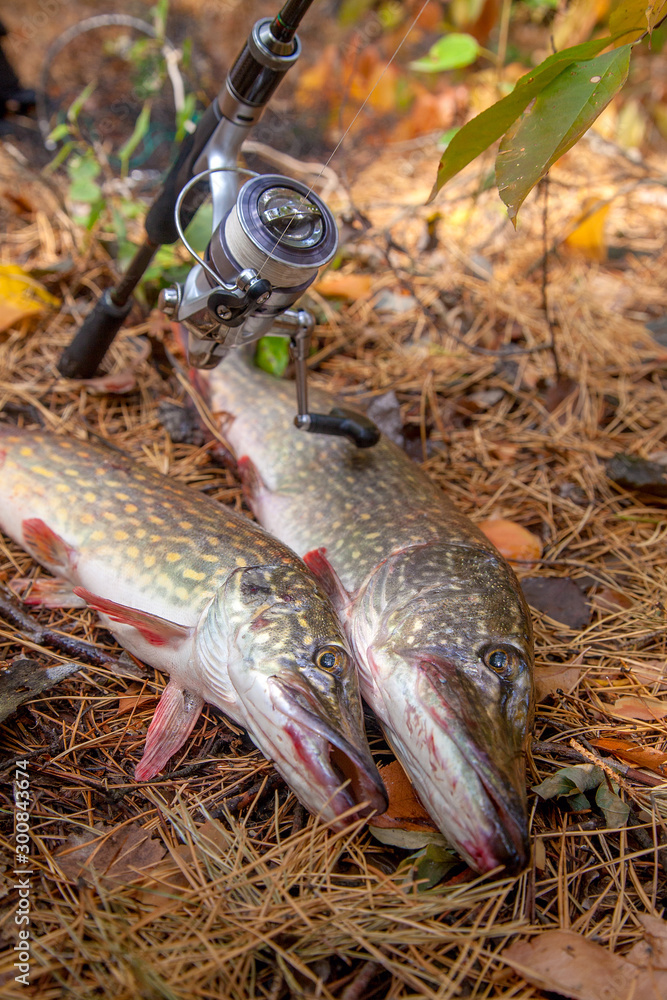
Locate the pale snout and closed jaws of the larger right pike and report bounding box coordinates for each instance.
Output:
[382,654,530,874]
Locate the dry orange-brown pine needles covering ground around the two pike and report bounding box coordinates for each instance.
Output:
[0,123,667,1000]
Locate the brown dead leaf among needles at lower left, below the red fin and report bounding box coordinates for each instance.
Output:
[55,823,165,885]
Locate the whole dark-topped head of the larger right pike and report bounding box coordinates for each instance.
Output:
[369,546,533,872]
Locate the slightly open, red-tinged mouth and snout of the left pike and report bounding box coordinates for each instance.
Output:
[272,677,388,830]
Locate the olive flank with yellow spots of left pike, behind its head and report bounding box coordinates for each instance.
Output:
[0,425,296,605]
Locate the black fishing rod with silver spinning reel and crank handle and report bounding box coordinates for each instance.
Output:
[58,0,380,448]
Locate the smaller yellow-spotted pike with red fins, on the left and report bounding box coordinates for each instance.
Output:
[0,424,386,825]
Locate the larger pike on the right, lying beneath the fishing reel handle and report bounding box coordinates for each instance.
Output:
[197,353,533,872]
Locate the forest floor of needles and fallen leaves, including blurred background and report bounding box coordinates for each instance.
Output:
[0,0,667,1000]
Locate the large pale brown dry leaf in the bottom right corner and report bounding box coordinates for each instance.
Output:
[502,918,667,1000]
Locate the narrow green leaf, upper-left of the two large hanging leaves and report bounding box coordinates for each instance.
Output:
[429,32,612,201]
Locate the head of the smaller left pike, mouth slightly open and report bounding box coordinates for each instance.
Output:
[217,560,387,828]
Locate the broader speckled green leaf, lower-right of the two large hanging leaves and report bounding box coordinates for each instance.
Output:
[496,45,631,222]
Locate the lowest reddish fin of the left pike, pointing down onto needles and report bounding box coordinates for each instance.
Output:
[134,681,204,781]
